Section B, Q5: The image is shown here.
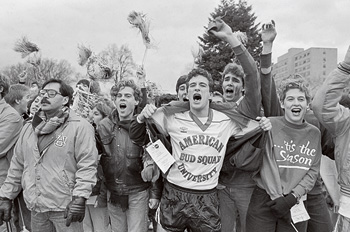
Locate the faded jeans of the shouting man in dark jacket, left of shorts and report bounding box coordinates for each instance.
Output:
[108,190,149,232]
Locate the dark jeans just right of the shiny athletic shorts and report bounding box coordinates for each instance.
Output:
[218,187,255,232]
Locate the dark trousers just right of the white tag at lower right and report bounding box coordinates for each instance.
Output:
[304,193,333,232]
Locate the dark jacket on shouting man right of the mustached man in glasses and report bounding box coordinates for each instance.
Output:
[98,110,161,199]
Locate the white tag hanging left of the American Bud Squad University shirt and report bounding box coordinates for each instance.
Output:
[146,139,175,174]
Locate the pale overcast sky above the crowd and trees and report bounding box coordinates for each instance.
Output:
[0,0,350,93]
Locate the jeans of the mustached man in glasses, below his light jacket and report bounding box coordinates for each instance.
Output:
[31,211,84,232]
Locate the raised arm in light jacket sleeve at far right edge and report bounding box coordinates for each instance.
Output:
[312,46,350,136]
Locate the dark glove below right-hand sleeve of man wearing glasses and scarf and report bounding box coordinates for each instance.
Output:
[64,197,86,226]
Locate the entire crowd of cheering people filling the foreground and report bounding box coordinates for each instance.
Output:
[0,19,350,232]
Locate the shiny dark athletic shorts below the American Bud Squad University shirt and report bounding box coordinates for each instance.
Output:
[160,181,221,232]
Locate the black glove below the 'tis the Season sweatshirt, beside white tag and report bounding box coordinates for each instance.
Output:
[266,193,297,223]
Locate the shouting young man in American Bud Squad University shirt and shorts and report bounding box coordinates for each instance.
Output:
[130,66,271,232]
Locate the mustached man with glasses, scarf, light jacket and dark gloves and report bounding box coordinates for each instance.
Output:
[0,79,97,232]
